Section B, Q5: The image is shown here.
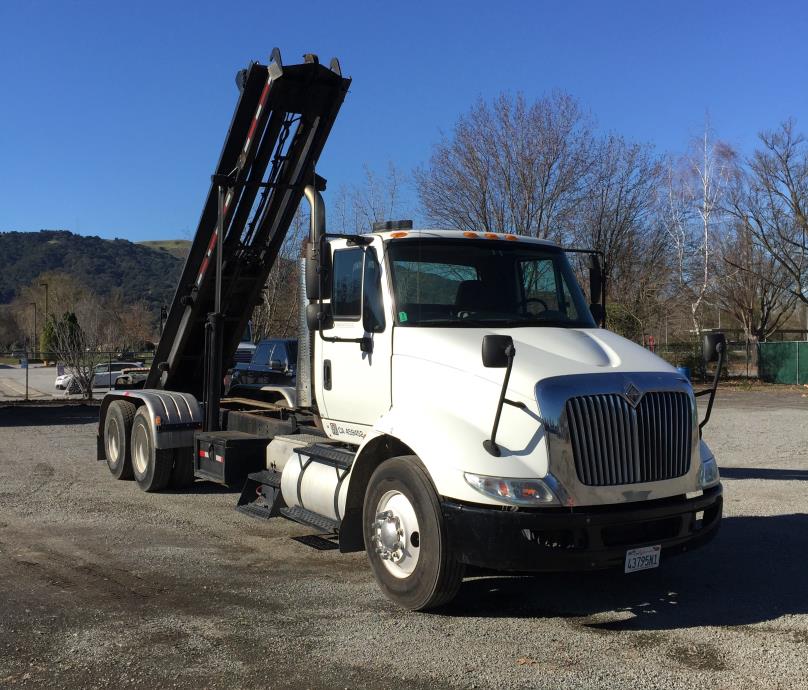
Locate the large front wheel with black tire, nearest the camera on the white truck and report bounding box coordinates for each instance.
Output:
[362,455,464,611]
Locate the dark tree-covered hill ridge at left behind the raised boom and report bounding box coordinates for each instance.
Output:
[0,230,187,307]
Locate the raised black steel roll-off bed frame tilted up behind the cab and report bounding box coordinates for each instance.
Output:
[146,49,351,398]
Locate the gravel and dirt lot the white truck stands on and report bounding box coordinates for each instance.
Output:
[0,391,808,688]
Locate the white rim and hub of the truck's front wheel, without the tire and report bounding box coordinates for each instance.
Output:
[370,491,421,579]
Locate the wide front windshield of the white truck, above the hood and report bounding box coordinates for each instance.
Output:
[387,239,595,328]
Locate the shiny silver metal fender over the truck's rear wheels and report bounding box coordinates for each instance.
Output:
[96,389,202,460]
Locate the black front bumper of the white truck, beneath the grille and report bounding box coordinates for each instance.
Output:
[441,484,723,572]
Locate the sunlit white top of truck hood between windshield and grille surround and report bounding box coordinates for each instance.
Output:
[393,327,676,398]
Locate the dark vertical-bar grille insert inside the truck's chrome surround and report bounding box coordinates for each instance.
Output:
[566,392,692,486]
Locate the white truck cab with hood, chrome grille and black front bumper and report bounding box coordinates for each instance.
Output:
[290,229,722,605]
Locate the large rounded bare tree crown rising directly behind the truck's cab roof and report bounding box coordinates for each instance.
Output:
[415,92,592,239]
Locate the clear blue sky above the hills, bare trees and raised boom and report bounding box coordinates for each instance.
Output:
[0,0,808,241]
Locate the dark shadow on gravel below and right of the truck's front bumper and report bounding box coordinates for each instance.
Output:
[442,514,808,630]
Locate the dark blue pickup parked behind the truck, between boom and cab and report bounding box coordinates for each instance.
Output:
[225,338,297,397]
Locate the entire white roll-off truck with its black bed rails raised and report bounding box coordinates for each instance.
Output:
[98,50,725,610]
